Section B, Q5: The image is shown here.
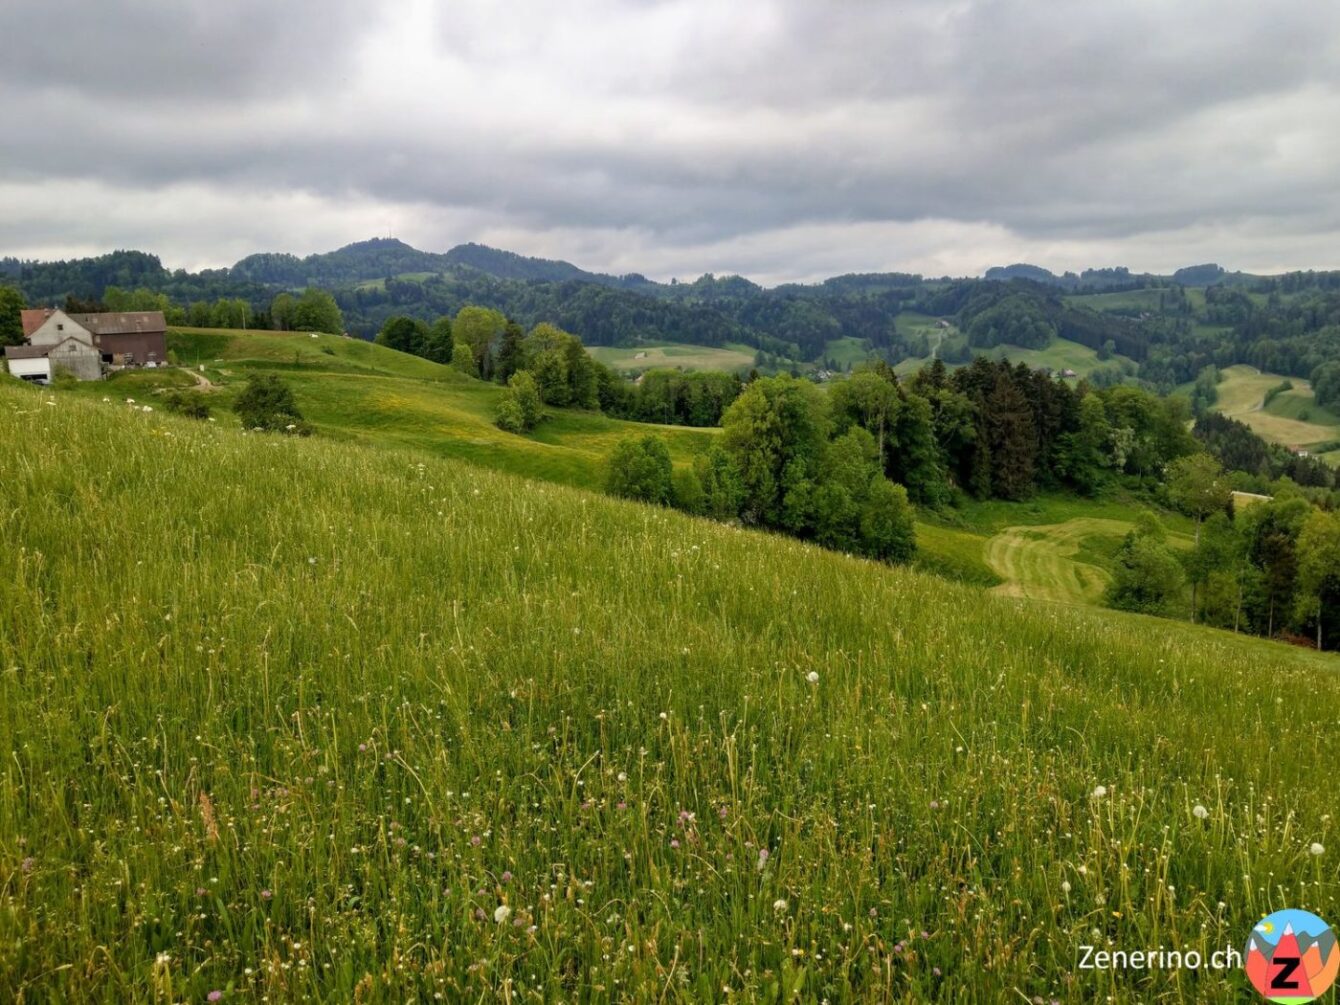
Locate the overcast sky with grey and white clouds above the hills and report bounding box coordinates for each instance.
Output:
[0,0,1340,283]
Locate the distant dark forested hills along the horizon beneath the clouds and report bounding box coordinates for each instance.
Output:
[0,239,1340,390]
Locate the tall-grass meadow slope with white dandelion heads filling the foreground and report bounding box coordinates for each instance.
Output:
[0,378,1340,1001]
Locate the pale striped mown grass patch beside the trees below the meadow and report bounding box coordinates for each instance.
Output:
[986,517,1131,604]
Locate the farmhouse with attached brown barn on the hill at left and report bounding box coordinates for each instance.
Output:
[5,307,168,383]
